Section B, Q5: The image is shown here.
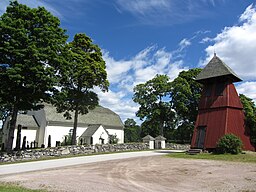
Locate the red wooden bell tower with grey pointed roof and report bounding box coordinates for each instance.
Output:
[191,54,255,151]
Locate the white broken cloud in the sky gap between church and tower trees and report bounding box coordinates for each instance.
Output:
[100,43,187,120]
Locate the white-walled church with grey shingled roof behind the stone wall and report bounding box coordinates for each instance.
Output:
[2,104,124,147]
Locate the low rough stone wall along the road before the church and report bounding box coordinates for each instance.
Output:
[0,143,189,162]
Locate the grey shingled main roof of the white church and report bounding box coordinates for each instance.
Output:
[43,104,124,129]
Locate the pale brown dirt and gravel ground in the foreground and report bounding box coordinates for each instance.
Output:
[0,156,256,192]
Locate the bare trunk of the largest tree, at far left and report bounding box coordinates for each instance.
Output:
[6,106,18,152]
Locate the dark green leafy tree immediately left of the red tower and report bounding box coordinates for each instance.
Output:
[171,68,202,142]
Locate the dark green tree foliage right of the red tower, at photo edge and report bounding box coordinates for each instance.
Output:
[239,94,256,147]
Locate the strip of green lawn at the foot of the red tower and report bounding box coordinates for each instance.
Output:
[167,152,256,163]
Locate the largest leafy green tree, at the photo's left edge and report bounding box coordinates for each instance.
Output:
[0,1,67,150]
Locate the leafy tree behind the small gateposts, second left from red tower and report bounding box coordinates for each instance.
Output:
[133,75,173,135]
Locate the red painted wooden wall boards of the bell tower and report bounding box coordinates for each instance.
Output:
[191,79,255,151]
